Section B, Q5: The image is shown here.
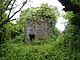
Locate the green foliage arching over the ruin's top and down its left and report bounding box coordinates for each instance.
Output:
[0,4,58,43]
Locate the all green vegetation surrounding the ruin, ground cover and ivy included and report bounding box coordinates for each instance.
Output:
[0,0,80,60]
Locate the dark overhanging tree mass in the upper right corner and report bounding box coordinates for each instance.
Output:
[58,0,80,14]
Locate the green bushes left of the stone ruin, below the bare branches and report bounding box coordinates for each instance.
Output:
[0,22,24,43]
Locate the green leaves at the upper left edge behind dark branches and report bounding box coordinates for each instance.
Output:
[0,0,11,27]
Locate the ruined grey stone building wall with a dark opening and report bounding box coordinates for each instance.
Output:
[24,19,52,42]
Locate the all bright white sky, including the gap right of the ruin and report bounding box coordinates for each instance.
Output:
[14,0,65,31]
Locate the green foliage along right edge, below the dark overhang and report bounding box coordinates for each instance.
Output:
[61,9,80,60]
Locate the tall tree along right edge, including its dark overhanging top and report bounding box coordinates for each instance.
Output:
[59,0,80,57]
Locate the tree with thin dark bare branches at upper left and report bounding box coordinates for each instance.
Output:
[0,0,27,27]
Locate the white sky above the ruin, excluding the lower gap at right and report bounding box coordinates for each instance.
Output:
[14,0,63,18]
